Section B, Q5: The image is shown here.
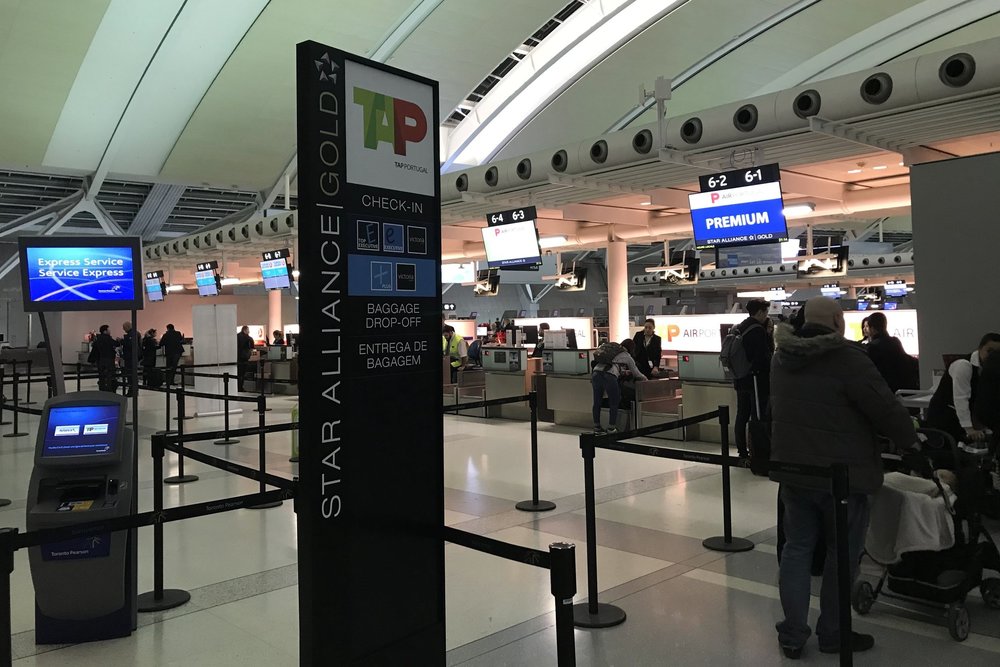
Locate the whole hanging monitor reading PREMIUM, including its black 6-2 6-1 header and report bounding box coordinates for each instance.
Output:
[688,164,788,249]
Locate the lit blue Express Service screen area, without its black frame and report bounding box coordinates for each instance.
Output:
[26,247,136,303]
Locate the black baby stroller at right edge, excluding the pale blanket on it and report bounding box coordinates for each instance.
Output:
[851,429,1000,641]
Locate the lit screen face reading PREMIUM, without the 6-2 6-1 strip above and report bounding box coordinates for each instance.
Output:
[688,183,788,248]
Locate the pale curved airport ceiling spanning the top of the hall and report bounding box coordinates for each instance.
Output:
[0,0,1000,240]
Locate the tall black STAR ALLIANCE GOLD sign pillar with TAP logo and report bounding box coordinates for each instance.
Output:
[296,42,445,665]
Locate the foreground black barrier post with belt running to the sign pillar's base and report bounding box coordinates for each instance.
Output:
[444,526,576,667]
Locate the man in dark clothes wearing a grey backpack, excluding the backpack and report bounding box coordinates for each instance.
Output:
[733,299,771,460]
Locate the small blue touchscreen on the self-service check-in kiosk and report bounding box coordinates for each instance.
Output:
[42,405,118,457]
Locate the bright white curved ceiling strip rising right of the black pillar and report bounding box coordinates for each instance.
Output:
[442,0,687,171]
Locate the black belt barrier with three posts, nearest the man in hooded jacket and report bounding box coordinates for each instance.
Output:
[573,405,854,667]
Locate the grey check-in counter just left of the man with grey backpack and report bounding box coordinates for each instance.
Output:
[677,352,736,443]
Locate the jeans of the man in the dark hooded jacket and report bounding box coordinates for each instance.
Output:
[775,484,868,647]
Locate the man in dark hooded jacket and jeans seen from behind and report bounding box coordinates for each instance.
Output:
[771,297,917,658]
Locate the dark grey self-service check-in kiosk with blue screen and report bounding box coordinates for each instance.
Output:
[27,391,136,644]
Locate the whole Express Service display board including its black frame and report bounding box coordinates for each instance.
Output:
[18,236,143,312]
